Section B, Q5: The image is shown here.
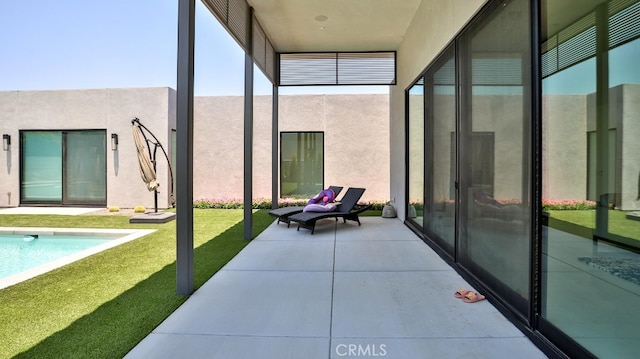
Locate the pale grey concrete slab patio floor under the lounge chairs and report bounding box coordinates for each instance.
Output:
[126,217,546,359]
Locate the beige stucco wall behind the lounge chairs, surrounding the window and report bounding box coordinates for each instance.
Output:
[193,95,389,201]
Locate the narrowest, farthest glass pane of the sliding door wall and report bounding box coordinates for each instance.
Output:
[407,78,424,227]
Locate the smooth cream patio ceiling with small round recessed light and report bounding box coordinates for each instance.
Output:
[247,0,422,52]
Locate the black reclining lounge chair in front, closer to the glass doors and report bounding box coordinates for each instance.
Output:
[288,188,371,234]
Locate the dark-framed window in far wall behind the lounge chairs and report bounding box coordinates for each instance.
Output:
[280,132,324,197]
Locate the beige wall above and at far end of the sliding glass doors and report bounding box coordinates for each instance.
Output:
[390,0,486,219]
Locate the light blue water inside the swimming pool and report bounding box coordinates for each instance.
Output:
[0,233,117,279]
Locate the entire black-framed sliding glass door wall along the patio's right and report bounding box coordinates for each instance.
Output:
[406,0,640,358]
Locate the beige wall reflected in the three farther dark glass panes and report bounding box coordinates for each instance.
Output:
[409,91,530,202]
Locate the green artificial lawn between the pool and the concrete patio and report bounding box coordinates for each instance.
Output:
[0,209,273,358]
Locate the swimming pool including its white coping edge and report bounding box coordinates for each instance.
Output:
[0,227,154,289]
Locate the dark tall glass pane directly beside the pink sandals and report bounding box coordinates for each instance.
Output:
[458,0,531,317]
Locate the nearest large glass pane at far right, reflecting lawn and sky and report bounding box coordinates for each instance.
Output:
[541,1,640,358]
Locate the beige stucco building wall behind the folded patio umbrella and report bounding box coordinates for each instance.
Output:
[0,87,174,208]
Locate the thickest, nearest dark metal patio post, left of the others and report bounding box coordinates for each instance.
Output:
[176,0,195,295]
